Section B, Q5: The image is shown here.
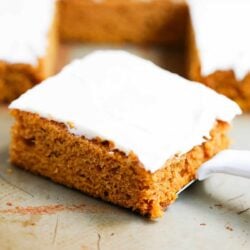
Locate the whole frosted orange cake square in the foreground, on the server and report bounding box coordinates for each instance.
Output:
[10,51,240,218]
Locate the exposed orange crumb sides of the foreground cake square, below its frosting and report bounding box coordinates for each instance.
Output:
[10,110,229,218]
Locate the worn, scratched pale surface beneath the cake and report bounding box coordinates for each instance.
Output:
[0,48,250,250]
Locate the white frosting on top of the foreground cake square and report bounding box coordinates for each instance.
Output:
[10,51,241,172]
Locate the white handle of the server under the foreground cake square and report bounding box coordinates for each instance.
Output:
[196,149,250,181]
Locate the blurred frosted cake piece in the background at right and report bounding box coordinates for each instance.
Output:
[188,0,250,111]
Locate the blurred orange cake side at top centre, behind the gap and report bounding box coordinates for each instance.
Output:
[59,0,188,44]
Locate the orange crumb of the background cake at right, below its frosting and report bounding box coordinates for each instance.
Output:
[187,26,250,112]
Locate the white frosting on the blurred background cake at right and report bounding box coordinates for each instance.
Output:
[188,0,250,81]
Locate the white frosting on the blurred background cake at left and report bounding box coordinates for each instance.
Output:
[0,0,55,66]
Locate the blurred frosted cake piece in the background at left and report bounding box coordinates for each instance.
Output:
[0,0,57,102]
